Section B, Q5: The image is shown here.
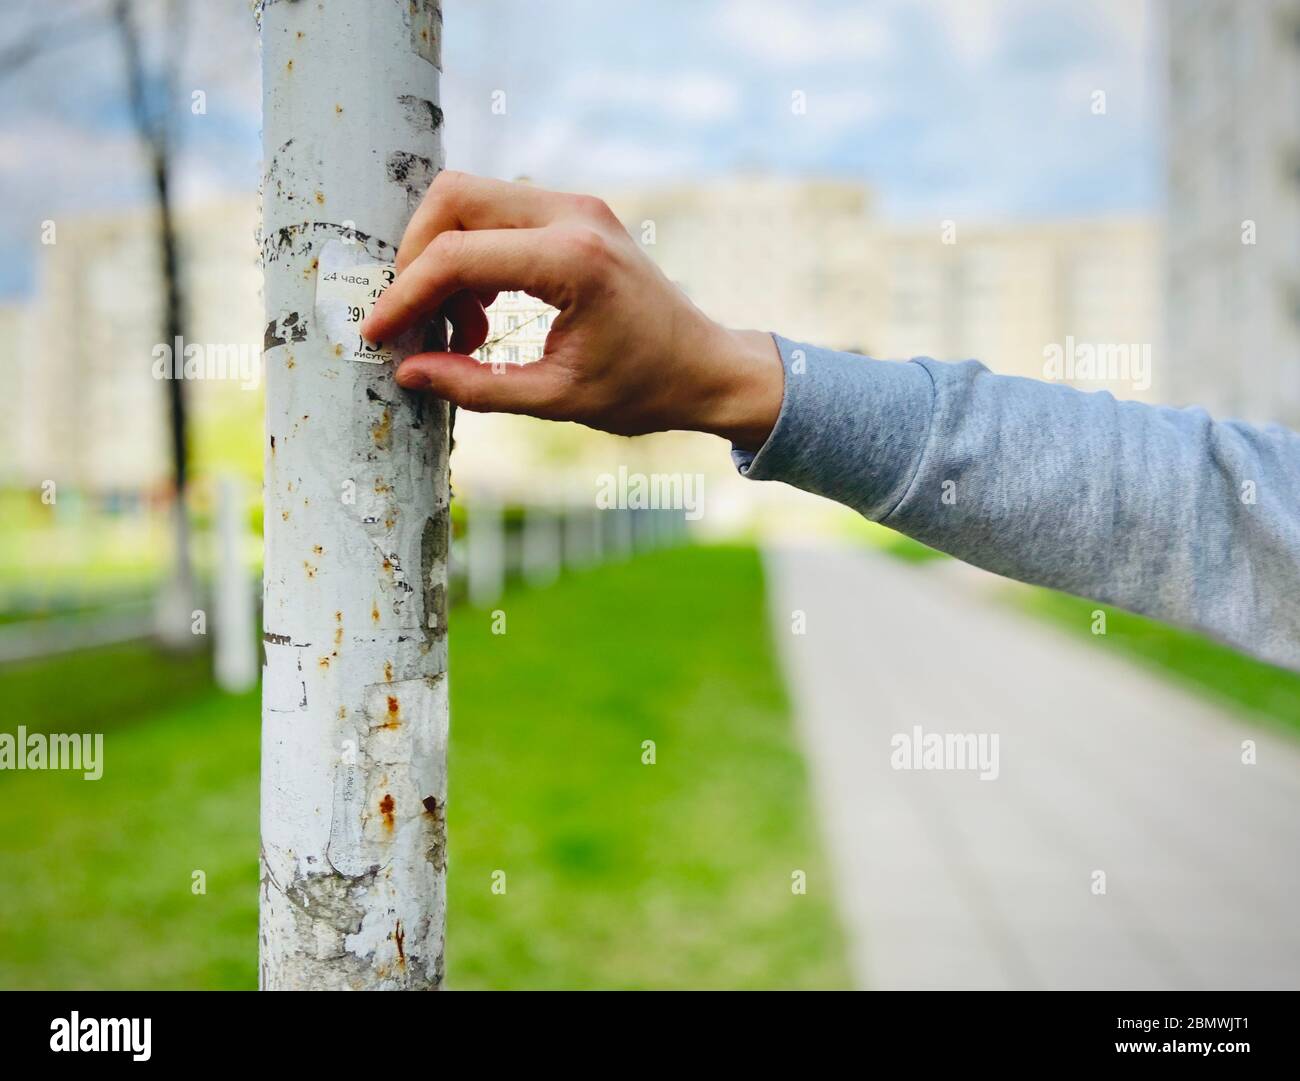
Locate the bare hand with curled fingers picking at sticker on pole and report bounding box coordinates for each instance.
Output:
[361,172,784,451]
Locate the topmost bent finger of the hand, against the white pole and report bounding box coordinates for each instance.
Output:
[397,170,577,273]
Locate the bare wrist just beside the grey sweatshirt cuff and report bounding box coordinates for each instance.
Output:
[702,327,785,451]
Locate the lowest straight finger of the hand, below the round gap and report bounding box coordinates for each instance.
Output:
[397,353,560,417]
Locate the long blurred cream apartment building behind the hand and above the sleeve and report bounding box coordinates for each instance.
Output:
[611,178,1161,398]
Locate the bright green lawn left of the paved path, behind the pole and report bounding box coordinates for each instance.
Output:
[0,548,848,987]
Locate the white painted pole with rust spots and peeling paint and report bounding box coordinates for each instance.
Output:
[256,0,449,990]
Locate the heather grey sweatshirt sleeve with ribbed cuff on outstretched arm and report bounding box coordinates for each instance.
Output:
[732,335,1300,668]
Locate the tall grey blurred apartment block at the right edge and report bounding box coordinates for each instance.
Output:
[1166,0,1300,427]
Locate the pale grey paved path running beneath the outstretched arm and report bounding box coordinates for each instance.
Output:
[764,547,1300,989]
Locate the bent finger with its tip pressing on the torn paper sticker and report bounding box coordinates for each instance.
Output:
[361,229,605,342]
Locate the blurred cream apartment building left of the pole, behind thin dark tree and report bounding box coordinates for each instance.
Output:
[0,199,261,495]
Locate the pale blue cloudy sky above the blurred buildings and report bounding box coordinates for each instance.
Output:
[0,0,1165,300]
